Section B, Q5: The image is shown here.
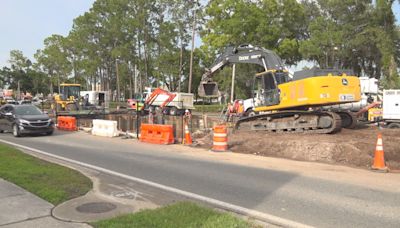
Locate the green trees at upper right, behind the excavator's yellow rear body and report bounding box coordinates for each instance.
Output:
[300,0,400,87]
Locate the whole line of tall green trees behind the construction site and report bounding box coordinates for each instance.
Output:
[0,0,400,98]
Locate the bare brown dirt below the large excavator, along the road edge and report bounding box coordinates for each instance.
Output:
[196,125,400,170]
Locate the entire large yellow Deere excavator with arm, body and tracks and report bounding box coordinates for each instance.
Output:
[198,44,361,133]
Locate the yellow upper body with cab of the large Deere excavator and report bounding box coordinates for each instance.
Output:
[255,70,361,112]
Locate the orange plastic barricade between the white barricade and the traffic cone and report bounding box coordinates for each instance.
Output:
[139,124,175,145]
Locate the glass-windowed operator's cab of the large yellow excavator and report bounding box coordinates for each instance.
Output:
[254,72,280,106]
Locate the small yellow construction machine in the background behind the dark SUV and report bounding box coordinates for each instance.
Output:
[54,83,81,111]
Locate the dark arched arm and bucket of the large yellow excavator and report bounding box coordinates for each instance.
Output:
[198,44,285,97]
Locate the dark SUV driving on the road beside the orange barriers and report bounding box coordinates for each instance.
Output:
[0,104,54,137]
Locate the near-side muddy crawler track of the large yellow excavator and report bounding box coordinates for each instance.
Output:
[235,110,342,134]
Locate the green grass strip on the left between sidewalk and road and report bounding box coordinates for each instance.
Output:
[0,144,92,205]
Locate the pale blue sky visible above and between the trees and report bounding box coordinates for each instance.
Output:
[0,0,400,68]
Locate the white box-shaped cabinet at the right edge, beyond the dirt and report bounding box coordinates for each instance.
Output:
[382,89,400,122]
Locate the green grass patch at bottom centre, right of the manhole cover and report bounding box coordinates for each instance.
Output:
[91,202,254,228]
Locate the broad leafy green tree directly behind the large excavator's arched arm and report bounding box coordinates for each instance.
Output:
[201,0,307,98]
